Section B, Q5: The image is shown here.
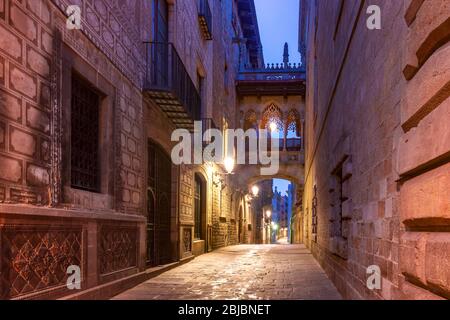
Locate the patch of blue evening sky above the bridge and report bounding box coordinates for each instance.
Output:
[254,0,300,64]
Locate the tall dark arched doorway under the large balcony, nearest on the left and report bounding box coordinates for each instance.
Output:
[147,140,172,266]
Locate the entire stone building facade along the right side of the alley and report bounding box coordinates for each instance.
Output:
[296,0,450,299]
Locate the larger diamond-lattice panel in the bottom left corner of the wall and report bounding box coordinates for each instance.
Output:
[0,225,83,299]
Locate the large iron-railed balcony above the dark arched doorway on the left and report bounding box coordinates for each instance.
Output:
[143,42,201,131]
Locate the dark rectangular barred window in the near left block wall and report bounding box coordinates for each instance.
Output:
[71,75,100,192]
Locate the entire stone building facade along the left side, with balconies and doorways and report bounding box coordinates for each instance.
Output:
[0,0,262,299]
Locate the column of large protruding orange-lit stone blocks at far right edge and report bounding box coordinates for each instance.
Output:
[398,0,450,299]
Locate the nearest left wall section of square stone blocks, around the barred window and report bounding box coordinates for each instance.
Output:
[0,0,149,298]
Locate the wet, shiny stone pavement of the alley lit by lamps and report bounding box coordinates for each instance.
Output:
[114,245,341,300]
